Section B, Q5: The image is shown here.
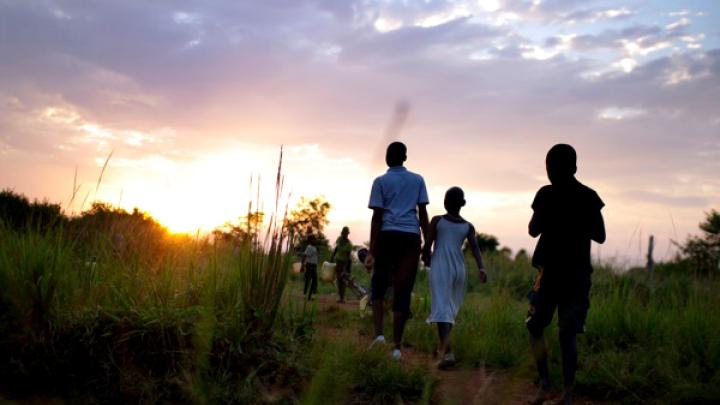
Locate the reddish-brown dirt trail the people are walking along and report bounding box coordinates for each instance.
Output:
[317,294,596,405]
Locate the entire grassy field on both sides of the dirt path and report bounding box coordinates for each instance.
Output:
[0,219,720,404]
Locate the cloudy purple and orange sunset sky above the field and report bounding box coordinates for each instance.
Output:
[0,0,720,264]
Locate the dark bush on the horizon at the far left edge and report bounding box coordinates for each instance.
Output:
[0,189,68,231]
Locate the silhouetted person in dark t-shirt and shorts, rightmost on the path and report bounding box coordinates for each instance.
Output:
[525,144,605,404]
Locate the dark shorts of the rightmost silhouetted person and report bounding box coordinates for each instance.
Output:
[525,269,591,336]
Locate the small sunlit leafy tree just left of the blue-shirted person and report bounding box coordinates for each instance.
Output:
[285,197,331,250]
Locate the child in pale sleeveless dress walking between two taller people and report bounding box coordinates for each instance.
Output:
[423,187,487,369]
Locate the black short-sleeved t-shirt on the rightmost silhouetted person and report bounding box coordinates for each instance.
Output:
[532,180,605,276]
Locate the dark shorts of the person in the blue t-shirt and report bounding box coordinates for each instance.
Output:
[371,231,420,313]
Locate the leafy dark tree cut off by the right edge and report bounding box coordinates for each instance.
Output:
[680,210,720,274]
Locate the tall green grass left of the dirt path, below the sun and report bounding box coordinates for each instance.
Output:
[0,148,312,403]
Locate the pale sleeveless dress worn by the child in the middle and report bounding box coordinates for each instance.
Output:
[427,218,470,323]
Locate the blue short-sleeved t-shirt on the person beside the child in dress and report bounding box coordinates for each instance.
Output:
[368,166,429,234]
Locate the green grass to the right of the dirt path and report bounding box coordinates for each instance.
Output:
[406,251,720,403]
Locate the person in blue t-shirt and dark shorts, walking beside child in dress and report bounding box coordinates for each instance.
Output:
[365,142,429,360]
